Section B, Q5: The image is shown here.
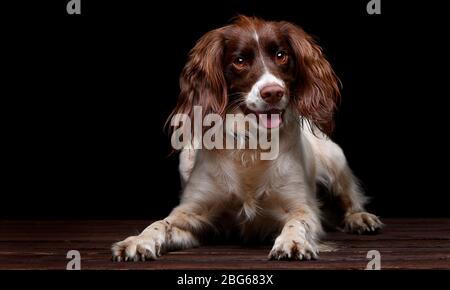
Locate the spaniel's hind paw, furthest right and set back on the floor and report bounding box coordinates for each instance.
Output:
[344,212,383,234]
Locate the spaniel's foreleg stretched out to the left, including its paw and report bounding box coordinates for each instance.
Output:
[111,204,209,261]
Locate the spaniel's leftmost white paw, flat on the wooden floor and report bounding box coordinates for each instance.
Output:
[111,236,162,262]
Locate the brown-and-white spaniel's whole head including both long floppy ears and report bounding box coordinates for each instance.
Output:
[174,16,339,133]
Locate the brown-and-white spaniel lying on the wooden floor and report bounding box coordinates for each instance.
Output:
[112,16,383,261]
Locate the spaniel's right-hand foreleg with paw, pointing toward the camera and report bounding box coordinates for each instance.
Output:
[269,206,322,260]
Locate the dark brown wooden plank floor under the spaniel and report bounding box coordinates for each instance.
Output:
[0,219,450,270]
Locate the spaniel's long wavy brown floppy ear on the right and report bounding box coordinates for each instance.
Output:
[280,22,340,134]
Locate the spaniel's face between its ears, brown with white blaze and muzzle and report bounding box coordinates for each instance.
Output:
[223,22,296,128]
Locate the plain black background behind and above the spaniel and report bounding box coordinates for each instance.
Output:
[0,0,450,219]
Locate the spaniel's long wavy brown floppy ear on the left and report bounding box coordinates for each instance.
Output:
[169,29,228,126]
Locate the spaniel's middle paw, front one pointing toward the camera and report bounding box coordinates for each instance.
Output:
[269,236,319,260]
